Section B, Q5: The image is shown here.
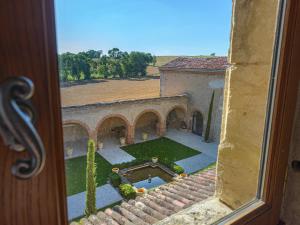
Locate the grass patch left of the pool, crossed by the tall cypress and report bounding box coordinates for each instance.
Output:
[66,153,112,196]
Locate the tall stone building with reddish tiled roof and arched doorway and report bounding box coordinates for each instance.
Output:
[160,57,228,142]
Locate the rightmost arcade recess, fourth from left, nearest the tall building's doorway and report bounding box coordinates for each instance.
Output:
[166,105,187,129]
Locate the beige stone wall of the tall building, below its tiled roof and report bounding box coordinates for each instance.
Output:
[160,70,225,141]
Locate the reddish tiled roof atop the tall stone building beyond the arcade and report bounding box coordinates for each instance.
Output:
[160,57,229,72]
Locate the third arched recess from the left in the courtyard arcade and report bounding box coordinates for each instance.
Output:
[133,109,165,139]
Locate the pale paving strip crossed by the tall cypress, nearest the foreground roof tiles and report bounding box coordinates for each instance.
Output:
[68,184,123,220]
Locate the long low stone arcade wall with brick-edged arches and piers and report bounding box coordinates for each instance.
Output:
[62,95,189,143]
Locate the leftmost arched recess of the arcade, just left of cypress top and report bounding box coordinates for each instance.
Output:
[63,120,91,158]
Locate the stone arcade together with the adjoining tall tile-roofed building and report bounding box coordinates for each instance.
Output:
[62,57,228,154]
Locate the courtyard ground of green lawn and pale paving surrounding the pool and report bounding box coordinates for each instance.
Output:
[66,129,217,220]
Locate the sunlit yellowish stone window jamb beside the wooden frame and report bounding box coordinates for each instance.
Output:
[216,0,278,209]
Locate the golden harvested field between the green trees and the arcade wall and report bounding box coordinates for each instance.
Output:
[61,79,160,106]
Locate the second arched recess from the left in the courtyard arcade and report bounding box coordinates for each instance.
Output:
[95,114,131,147]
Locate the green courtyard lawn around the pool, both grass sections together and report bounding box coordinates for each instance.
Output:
[66,137,200,196]
